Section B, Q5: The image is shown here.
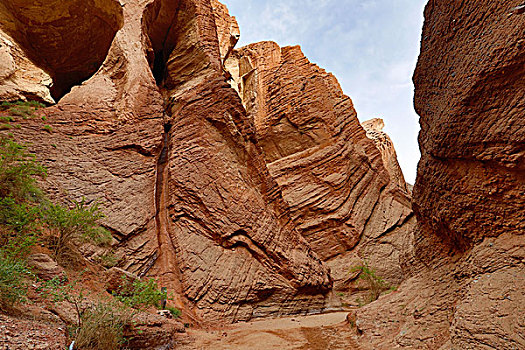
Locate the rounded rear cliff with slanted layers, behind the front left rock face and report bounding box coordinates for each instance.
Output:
[226,42,414,288]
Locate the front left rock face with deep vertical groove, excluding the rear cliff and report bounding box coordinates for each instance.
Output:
[2,0,332,322]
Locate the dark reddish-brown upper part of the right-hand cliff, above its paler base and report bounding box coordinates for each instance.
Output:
[414,0,525,258]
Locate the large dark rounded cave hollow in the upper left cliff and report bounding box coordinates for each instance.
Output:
[0,0,123,102]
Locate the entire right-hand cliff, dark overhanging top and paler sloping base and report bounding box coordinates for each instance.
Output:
[357,0,525,349]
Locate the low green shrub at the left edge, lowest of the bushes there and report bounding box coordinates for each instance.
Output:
[0,251,31,310]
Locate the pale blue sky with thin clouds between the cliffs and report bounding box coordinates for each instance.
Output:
[221,0,427,184]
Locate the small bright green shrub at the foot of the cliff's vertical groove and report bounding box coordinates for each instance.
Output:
[115,276,167,309]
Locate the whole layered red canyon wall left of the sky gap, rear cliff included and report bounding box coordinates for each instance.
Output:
[0,0,422,336]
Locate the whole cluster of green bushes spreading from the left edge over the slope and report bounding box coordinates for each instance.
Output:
[0,135,111,308]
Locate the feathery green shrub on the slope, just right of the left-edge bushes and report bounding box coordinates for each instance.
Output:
[42,199,111,260]
